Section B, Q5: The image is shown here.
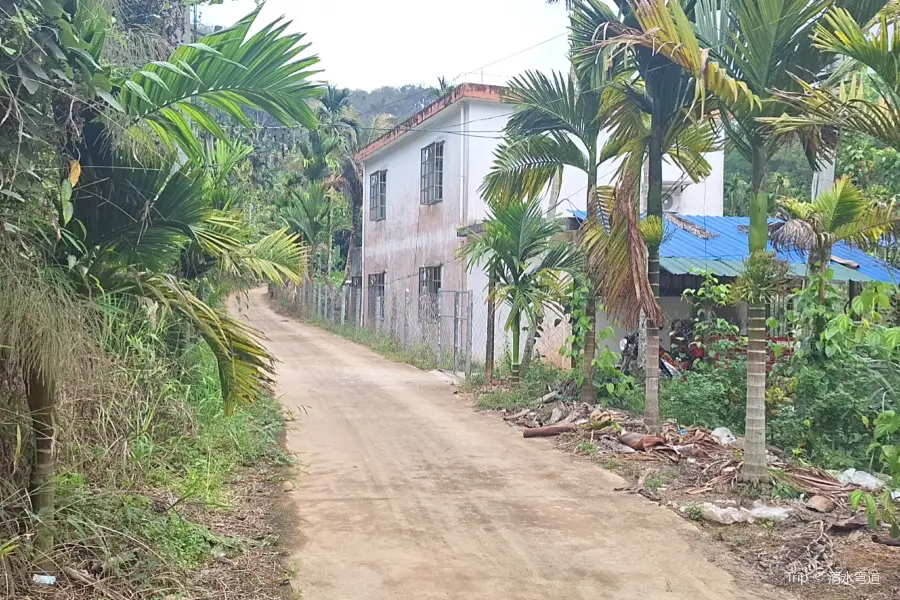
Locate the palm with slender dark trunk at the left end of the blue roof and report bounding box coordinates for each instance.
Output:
[572,0,716,430]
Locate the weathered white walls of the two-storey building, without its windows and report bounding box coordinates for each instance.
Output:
[362,99,724,363]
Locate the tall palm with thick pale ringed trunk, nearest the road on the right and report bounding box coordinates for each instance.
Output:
[604,0,884,482]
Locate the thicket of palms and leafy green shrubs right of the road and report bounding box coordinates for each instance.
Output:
[468,0,900,528]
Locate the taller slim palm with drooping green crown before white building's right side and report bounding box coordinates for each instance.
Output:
[481,71,605,403]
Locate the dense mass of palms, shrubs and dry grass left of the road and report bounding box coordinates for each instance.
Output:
[0,0,323,596]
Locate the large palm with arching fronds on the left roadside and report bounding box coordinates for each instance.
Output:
[12,4,319,570]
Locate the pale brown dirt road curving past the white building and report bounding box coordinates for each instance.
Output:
[237,290,788,600]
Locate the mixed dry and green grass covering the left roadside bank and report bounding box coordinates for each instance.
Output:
[0,311,289,598]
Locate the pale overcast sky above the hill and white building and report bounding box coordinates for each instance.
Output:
[200,0,567,90]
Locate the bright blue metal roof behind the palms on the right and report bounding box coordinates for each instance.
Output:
[571,210,900,283]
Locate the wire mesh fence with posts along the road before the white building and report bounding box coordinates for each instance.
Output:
[270,279,570,377]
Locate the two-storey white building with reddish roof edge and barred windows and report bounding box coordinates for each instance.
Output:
[354,84,724,366]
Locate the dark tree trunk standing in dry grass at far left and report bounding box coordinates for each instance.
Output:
[26,370,55,574]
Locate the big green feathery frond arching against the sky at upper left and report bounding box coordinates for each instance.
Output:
[113,10,322,155]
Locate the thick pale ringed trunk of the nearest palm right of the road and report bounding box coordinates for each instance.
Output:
[741,146,769,483]
